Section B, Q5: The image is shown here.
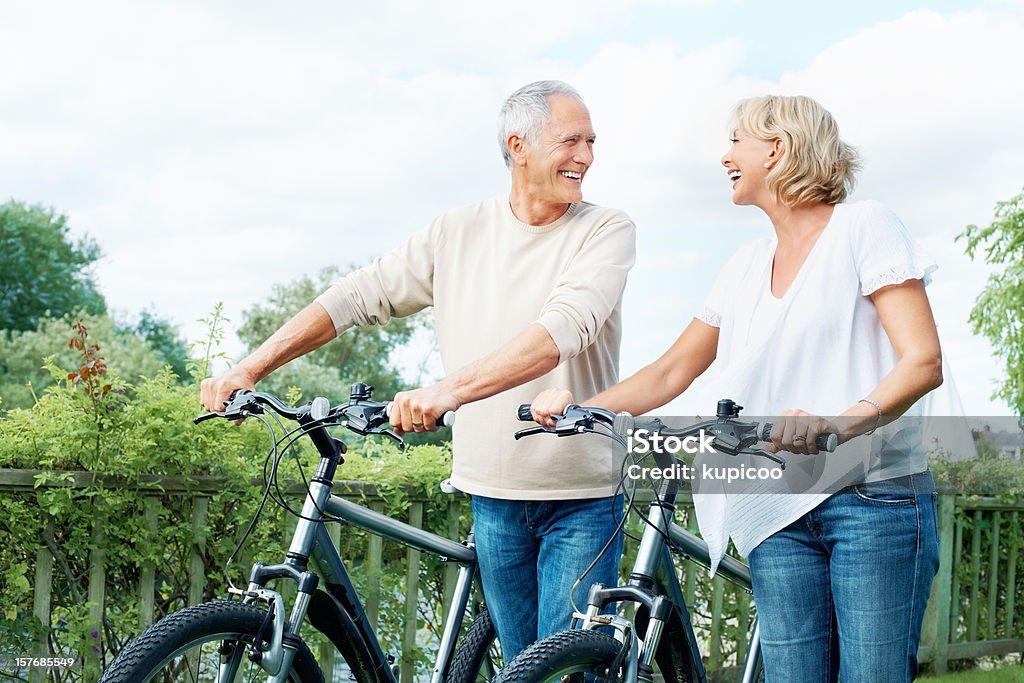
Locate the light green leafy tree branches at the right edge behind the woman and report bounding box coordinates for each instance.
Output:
[956,185,1024,415]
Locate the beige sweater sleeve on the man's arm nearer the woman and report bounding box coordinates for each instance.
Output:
[537,213,636,362]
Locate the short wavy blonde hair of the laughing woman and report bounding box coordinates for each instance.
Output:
[732,95,860,207]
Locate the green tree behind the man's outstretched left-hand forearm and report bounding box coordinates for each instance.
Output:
[238,267,434,400]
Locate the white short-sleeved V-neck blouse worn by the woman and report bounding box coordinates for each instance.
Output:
[694,201,937,566]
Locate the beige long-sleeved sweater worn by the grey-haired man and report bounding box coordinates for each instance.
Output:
[316,197,635,500]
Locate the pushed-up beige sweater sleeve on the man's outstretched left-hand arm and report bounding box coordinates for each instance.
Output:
[316,218,442,334]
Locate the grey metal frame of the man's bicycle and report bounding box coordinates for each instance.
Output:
[234,432,477,683]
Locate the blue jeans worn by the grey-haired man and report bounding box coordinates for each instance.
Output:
[473,496,623,661]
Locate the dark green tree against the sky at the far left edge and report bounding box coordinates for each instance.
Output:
[0,201,106,330]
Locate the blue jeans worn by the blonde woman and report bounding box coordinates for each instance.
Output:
[750,472,939,683]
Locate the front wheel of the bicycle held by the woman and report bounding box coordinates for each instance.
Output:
[496,631,623,683]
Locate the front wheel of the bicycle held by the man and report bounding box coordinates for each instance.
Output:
[100,601,324,683]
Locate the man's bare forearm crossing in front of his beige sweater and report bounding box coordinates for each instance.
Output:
[441,323,559,403]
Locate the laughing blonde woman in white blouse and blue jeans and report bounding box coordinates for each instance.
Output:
[532,96,942,683]
